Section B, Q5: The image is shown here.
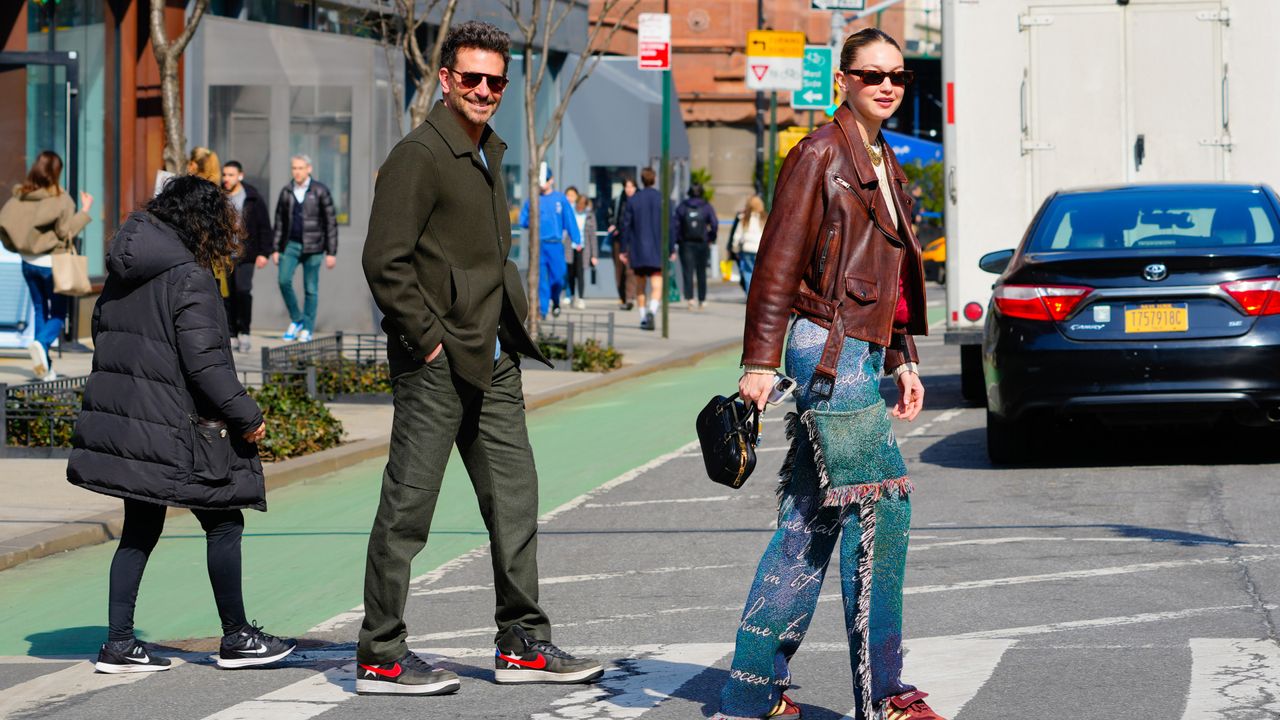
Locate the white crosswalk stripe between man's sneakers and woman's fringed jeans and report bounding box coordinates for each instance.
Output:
[531,643,733,720]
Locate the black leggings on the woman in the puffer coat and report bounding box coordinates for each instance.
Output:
[108,491,248,641]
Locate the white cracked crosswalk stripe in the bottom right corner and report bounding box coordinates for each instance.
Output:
[1183,638,1280,720]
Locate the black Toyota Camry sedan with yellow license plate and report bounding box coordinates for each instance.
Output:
[980,184,1280,462]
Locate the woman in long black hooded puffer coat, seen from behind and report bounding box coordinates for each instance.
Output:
[67,176,296,673]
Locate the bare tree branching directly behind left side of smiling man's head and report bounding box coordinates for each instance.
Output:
[378,0,458,127]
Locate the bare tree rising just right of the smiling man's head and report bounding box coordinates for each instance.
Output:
[503,0,640,337]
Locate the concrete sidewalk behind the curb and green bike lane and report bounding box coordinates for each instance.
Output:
[0,283,745,570]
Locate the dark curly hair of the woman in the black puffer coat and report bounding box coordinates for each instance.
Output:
[143,176,244,270]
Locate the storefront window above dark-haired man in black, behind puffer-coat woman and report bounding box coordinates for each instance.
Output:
[209,85,273,196]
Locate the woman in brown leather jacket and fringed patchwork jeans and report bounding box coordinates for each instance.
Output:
[717,28,941,720]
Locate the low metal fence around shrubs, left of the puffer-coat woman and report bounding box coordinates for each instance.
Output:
[0,375,88,455]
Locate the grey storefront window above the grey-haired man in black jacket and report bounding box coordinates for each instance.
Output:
[289,86,352,225]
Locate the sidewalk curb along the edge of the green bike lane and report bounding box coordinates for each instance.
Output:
[0,338,742,571]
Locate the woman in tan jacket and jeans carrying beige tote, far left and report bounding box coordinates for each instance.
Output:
[0,150,93,380]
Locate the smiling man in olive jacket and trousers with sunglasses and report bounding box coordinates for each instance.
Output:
[356,22,604,694]
